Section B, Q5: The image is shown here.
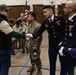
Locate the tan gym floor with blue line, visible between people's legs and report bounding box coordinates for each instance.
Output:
[9,31,60,75]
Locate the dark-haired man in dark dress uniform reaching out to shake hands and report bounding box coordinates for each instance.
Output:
[27,5,67,75]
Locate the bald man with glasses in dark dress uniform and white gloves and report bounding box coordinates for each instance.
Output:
[59,1,76,75]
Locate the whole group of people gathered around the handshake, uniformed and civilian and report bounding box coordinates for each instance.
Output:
[0,1,76,75]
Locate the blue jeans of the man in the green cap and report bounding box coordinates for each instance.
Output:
[0,49,11,75]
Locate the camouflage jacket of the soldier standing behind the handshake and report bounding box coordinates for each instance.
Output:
[28,21,42,49]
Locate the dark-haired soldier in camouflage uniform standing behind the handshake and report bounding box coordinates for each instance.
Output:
[27,12,42,75]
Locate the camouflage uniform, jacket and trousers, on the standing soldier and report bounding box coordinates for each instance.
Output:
[28,21,42,69]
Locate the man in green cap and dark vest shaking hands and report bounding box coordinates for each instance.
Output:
[0,4,26,75]
